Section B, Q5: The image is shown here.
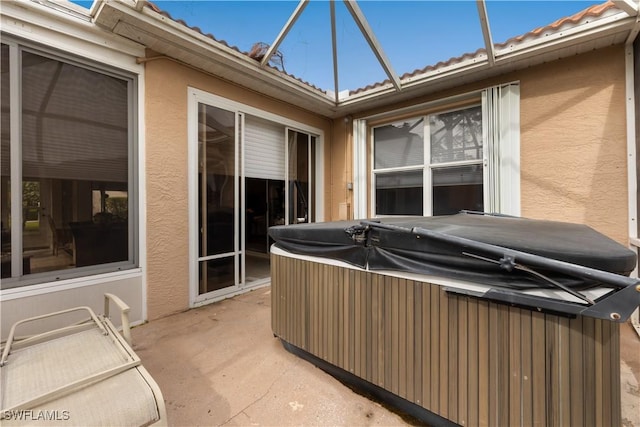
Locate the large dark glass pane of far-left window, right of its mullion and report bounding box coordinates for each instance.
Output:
[21,52,131,274]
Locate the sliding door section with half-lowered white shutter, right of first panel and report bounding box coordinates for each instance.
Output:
[243,125,316,284]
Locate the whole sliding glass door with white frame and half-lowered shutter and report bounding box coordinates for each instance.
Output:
[190,91,317,304]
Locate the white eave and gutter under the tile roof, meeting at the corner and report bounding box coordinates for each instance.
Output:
[95,0,637,118]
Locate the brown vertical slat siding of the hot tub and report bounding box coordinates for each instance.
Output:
[271,254,621,426]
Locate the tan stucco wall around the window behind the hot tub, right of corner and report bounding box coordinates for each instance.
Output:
[331,46,628,245]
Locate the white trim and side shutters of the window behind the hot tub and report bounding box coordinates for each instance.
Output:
[353,82,520,219]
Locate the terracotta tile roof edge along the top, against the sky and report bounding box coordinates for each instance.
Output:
[145,0,619,95]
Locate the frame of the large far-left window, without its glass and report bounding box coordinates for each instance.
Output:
[0,38,142,293]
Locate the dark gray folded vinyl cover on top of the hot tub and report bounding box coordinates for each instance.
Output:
[269,212,640,320]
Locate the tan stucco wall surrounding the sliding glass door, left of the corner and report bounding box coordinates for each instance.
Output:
[145,59,333,320]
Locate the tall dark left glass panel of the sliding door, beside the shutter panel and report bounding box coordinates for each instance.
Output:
[198,104,239,295]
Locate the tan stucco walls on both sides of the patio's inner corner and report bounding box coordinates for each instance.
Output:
[145,47,628,319]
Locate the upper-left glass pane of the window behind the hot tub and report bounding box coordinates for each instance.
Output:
[373,118,424,169]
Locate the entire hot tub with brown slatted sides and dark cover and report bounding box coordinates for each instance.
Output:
[270,213,640,426]
